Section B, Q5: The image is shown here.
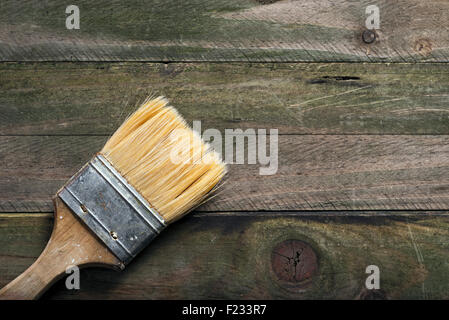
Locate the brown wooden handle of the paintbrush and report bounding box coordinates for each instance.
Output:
[0,197,122,300]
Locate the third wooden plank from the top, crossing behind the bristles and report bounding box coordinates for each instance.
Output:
[0,135,449,212]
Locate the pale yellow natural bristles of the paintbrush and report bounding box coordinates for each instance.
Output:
[101,97,226,223]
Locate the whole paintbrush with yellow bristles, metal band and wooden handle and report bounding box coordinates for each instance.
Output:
[0,97,226,299]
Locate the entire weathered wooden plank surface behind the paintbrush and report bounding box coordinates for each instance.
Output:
[0,0,449,299]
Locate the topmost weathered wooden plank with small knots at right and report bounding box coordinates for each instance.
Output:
[0,0,449,62]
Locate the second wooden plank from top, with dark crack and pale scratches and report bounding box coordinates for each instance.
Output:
[0,63,449,135]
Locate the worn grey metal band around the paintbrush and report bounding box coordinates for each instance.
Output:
[58,154,166,265]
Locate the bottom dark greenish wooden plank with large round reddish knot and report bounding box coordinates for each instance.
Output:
[0,214,449,299]
